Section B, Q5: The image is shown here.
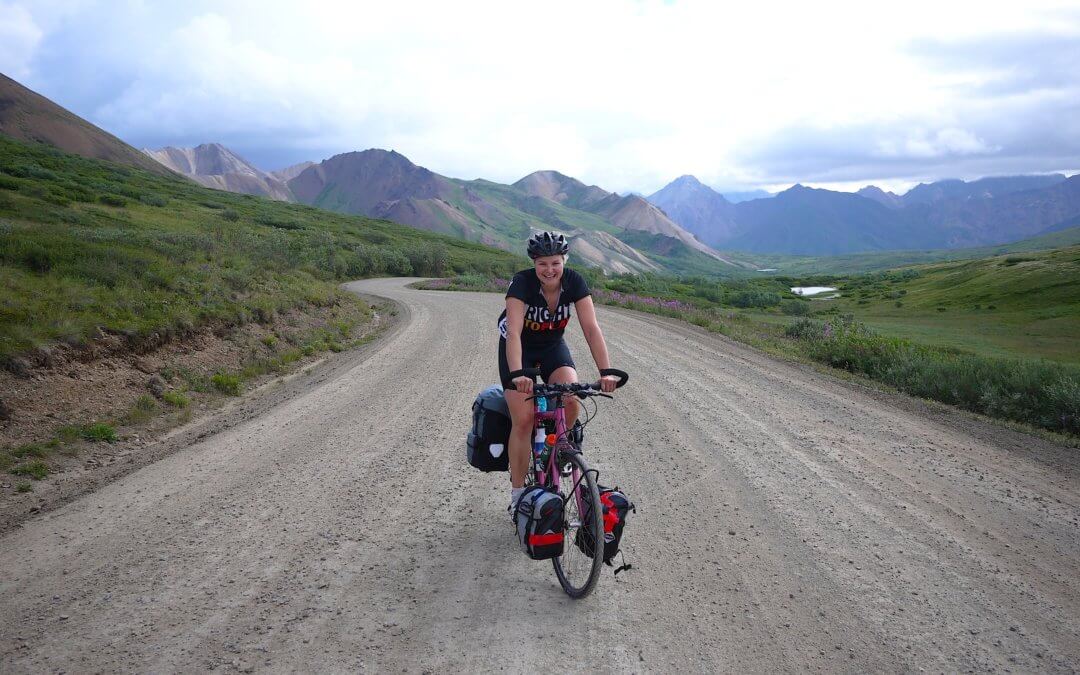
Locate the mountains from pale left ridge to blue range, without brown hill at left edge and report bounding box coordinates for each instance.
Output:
[144,139,742,273]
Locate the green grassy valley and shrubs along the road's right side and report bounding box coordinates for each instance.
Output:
[416,246,1080,437]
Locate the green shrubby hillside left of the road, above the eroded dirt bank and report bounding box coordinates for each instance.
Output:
[0,136,524,361]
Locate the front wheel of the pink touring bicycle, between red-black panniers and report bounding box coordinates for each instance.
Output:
[551,453,604,598]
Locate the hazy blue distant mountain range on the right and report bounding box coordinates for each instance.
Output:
[648,174,1080,256]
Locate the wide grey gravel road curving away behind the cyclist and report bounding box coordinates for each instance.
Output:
[0,280,1080,672]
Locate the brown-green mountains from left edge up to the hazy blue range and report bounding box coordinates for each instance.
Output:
[0,76,725,273]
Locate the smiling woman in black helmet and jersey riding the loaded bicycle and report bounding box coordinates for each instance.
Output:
[499,232,619,513]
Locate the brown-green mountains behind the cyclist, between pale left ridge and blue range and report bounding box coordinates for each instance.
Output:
[287,149,726,273]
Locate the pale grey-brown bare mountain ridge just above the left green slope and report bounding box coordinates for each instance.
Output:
[143,143,295,202]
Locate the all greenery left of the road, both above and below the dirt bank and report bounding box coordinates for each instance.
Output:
[0,135,524,483]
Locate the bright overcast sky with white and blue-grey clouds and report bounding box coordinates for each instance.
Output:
[0,0,1080,193]
